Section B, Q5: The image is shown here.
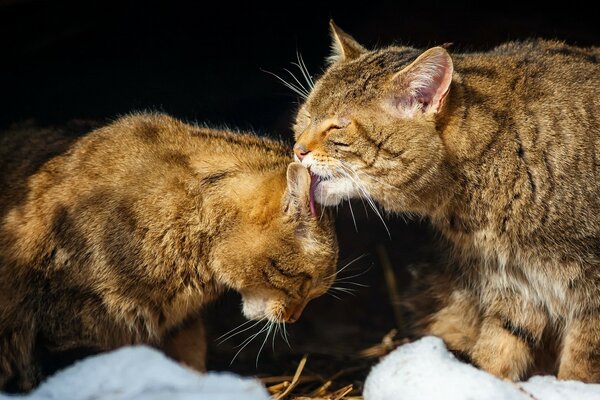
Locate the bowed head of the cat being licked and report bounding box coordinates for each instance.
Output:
[212,163,338,322]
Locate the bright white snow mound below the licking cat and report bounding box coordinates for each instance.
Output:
[364,337,600,400]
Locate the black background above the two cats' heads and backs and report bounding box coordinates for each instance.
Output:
[0,0,600,137]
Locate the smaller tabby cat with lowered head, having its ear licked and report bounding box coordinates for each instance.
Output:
[0,114,337,390]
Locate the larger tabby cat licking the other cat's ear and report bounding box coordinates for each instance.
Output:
[294,23,600,382]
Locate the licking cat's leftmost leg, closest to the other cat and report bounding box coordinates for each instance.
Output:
[424,289,481,359]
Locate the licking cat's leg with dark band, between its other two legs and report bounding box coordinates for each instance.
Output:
[472,295,548,380]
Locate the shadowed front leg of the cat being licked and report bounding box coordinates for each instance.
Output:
[163,317,206,372]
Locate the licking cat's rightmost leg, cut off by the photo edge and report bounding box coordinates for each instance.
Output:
[558,313,600,383]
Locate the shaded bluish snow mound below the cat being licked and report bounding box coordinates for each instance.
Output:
[0,346,270,400]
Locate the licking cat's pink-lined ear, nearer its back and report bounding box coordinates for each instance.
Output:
[391,47,454,117]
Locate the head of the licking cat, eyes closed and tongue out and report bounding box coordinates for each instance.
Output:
[294,22,453,211]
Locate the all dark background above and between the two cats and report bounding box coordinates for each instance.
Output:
[0,0,600,394]
